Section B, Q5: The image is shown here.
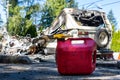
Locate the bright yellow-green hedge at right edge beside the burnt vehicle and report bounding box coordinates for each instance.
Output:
[111,31,120,52]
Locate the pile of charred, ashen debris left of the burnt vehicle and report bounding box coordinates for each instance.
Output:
[0,27,45,63]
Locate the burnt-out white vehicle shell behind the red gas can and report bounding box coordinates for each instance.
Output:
[44,8,113,58]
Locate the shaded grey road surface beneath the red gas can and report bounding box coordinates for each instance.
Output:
[0,57,120,80]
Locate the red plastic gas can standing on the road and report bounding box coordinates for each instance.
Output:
[56,38,96,75]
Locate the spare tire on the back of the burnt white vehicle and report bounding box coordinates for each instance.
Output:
[95,29,110,48]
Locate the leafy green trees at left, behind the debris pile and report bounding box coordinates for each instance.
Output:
[7,0,40,37]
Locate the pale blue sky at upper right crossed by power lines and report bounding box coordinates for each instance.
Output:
[76,0,120,29]
